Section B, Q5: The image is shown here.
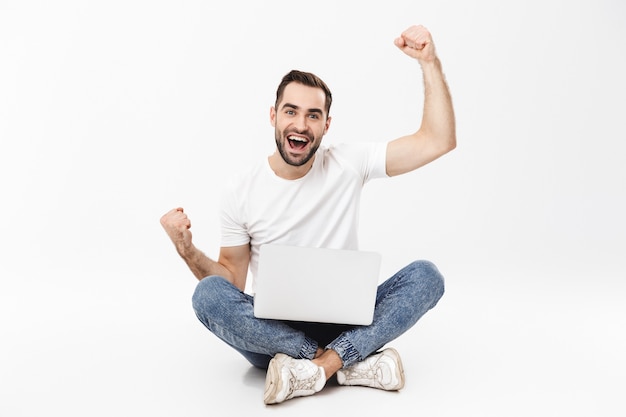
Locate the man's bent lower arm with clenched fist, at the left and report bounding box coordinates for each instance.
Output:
[161,207,250,291]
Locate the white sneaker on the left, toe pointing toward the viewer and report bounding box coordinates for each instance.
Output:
[263,353,326,404]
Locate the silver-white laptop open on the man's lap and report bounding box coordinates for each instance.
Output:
[254,244,381,325]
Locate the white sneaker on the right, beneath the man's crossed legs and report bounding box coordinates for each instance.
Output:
[337,348,404,391]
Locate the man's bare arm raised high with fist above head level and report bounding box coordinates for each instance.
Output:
[386,26,456,176]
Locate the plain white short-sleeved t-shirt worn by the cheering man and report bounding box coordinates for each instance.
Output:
[221,142,387,288]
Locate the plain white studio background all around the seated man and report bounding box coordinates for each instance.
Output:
[0,0,626,416]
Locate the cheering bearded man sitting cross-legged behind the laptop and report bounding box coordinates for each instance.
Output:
[161,26,456,404]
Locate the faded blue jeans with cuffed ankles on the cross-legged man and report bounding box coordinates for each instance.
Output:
[192,261,444,368]
